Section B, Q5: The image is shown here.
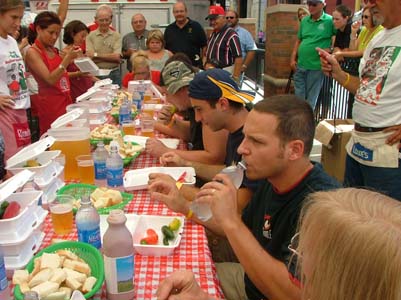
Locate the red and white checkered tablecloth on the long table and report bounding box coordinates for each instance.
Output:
[22,149,224,300]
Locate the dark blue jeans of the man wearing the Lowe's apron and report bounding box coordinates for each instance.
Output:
[344,154,401,201]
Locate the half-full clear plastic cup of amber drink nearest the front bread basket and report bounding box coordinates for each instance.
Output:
[49,195,74,235]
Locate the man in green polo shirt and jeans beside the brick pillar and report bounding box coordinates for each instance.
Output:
[291,0,336,108]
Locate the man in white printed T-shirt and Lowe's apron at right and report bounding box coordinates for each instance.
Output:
[319,0,401,201]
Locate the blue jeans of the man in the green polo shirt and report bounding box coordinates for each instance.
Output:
[294,67,324,109]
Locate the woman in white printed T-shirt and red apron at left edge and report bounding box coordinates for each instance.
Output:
[0,0,31,161]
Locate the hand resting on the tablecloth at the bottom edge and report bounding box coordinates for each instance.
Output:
[156,270,210,300]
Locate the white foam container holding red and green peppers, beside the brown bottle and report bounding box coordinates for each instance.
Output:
[132,215,185,256]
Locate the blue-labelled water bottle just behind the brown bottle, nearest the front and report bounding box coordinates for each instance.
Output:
[75,196,102,249]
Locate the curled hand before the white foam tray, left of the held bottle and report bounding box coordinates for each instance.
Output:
[148,173,189,215]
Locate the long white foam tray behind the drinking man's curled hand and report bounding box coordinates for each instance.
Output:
[124,167,196,191]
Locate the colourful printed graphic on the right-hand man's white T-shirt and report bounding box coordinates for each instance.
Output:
[355,46,401,106]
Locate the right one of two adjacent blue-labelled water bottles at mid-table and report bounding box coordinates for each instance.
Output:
[106,141,124,191]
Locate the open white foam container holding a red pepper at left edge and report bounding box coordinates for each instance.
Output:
[0,191,47,244]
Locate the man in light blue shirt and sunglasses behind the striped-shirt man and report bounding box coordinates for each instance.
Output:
[226,10,257,78]
